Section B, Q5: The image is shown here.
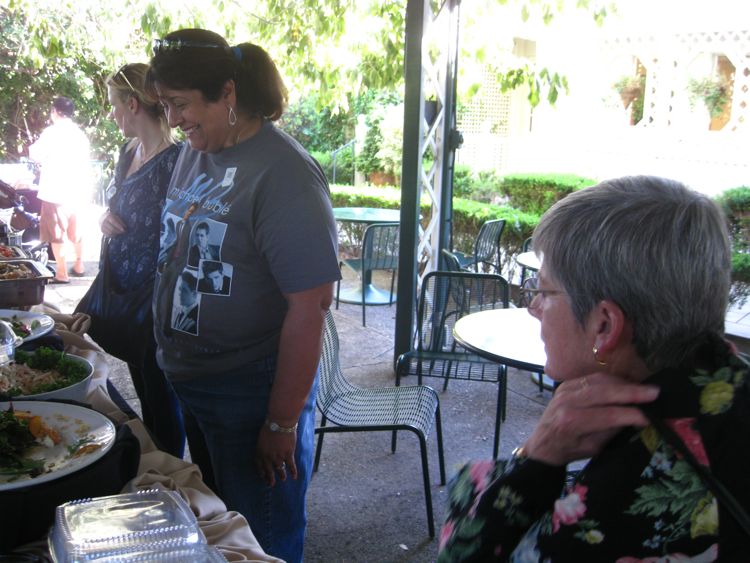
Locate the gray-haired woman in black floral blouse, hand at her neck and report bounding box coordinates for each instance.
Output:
[439,176,750,563]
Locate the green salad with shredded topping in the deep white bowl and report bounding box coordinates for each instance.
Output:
[0,347,89,397]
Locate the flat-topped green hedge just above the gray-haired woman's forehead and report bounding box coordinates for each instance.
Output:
[499,174,596,215]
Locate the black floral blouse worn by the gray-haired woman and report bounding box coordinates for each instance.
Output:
[438,337,750,563]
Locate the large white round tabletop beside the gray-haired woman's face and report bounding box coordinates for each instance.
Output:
[453,308,547,372]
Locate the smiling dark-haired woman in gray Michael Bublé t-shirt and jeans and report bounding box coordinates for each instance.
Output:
[150,29,340,561]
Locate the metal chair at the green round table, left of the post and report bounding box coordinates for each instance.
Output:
[336,223,399,326]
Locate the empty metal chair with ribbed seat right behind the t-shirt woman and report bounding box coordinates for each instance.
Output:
[313,311,445,537]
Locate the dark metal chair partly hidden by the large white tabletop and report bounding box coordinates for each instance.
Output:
[396,271,509,457]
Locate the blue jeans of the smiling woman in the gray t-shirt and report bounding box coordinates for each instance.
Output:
[173,357,318,563]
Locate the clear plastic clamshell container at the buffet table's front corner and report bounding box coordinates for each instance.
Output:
[49,490,210,563]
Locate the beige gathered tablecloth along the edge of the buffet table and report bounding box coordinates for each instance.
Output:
[11,309,281,562]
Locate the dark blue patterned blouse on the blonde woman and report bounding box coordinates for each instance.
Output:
[105,141,182,291]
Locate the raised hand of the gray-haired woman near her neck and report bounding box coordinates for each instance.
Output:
[524,373,659,465]
